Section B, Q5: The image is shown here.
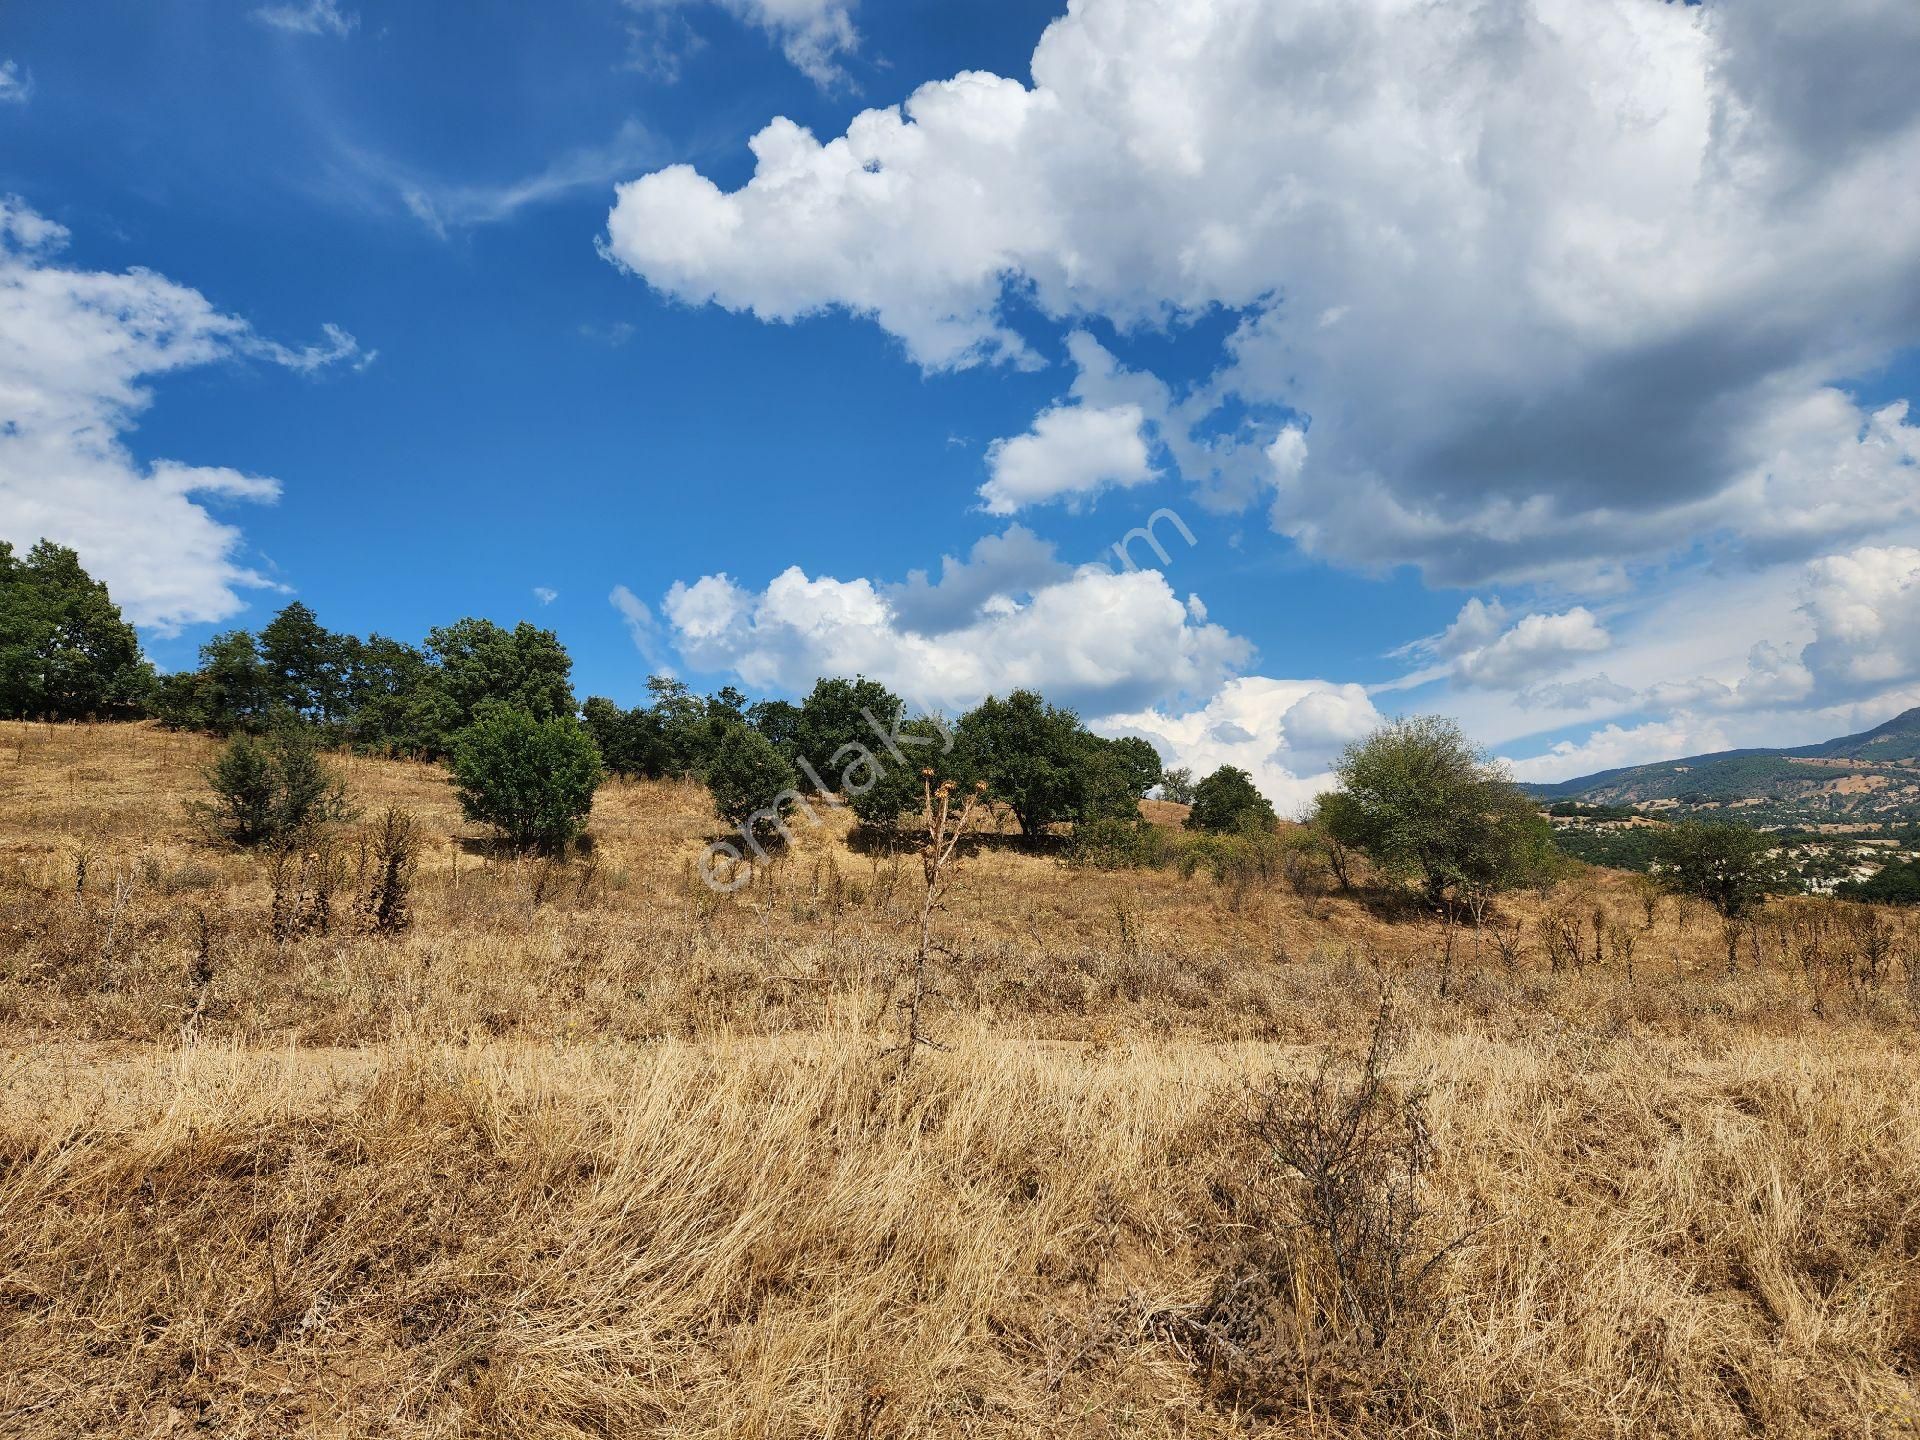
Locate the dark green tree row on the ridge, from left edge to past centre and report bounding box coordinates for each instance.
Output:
[0,541,1160,839]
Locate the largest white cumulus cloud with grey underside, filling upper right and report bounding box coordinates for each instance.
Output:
[607,0,1920,584]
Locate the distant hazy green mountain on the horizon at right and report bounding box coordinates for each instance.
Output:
[1526,707,1920,833]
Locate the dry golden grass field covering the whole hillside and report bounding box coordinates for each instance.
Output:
[0,724,1920,1440]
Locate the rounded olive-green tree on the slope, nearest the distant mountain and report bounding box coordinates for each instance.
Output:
[1323,716,1553,904]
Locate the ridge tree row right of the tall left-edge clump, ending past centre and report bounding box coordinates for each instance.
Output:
[139,601,1160,835]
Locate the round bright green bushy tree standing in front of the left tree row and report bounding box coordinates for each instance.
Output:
[453,703,607,854]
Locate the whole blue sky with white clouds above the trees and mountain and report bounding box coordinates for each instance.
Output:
[0,0,1920,814]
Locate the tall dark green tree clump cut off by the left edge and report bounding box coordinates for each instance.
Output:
[0,540,156,720]
